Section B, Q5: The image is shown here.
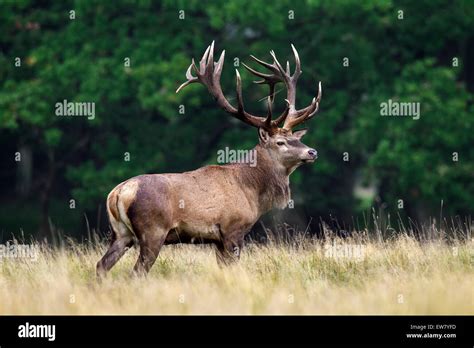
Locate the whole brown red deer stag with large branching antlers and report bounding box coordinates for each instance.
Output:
[96,41,322,279]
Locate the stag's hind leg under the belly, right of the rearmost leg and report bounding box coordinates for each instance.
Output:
[133,227,169,276]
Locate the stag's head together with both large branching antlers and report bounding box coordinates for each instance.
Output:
[176,41,322,173]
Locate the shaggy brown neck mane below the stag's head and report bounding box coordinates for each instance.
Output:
[239,144,290,214]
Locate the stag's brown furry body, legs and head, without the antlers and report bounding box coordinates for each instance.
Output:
[97,132,314,276]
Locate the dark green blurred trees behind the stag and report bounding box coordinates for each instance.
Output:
[0,0,474,238]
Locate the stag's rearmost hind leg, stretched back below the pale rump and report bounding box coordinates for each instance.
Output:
[97,220,133,280]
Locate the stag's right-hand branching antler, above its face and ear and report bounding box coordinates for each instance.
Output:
[243,45,322,131]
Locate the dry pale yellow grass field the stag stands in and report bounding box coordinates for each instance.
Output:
[0,230,474,315]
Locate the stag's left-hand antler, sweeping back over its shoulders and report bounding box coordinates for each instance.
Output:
[176,41,289,132]
